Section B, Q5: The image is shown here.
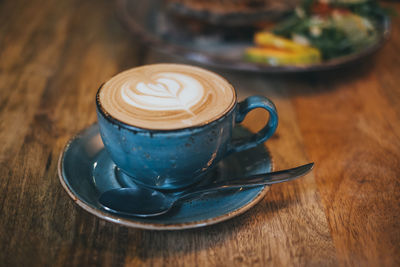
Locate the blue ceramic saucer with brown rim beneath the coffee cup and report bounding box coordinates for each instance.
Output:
[58,124,272,230]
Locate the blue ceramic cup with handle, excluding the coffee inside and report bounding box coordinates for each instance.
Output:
[96,71,278,190]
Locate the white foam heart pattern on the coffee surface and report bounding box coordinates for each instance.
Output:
[121,73,204,114]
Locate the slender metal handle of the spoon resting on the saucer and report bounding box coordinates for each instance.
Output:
[179,163,314,201]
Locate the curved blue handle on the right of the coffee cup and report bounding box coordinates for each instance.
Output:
[228,96,278,154]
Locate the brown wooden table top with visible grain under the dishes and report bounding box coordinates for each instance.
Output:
[0,0,400,266]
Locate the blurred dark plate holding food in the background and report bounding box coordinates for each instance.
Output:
[117,0,390,73]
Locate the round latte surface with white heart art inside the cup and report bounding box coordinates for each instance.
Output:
[98,64,236,130]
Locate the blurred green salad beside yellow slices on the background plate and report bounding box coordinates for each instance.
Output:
[273,0,387,60]
